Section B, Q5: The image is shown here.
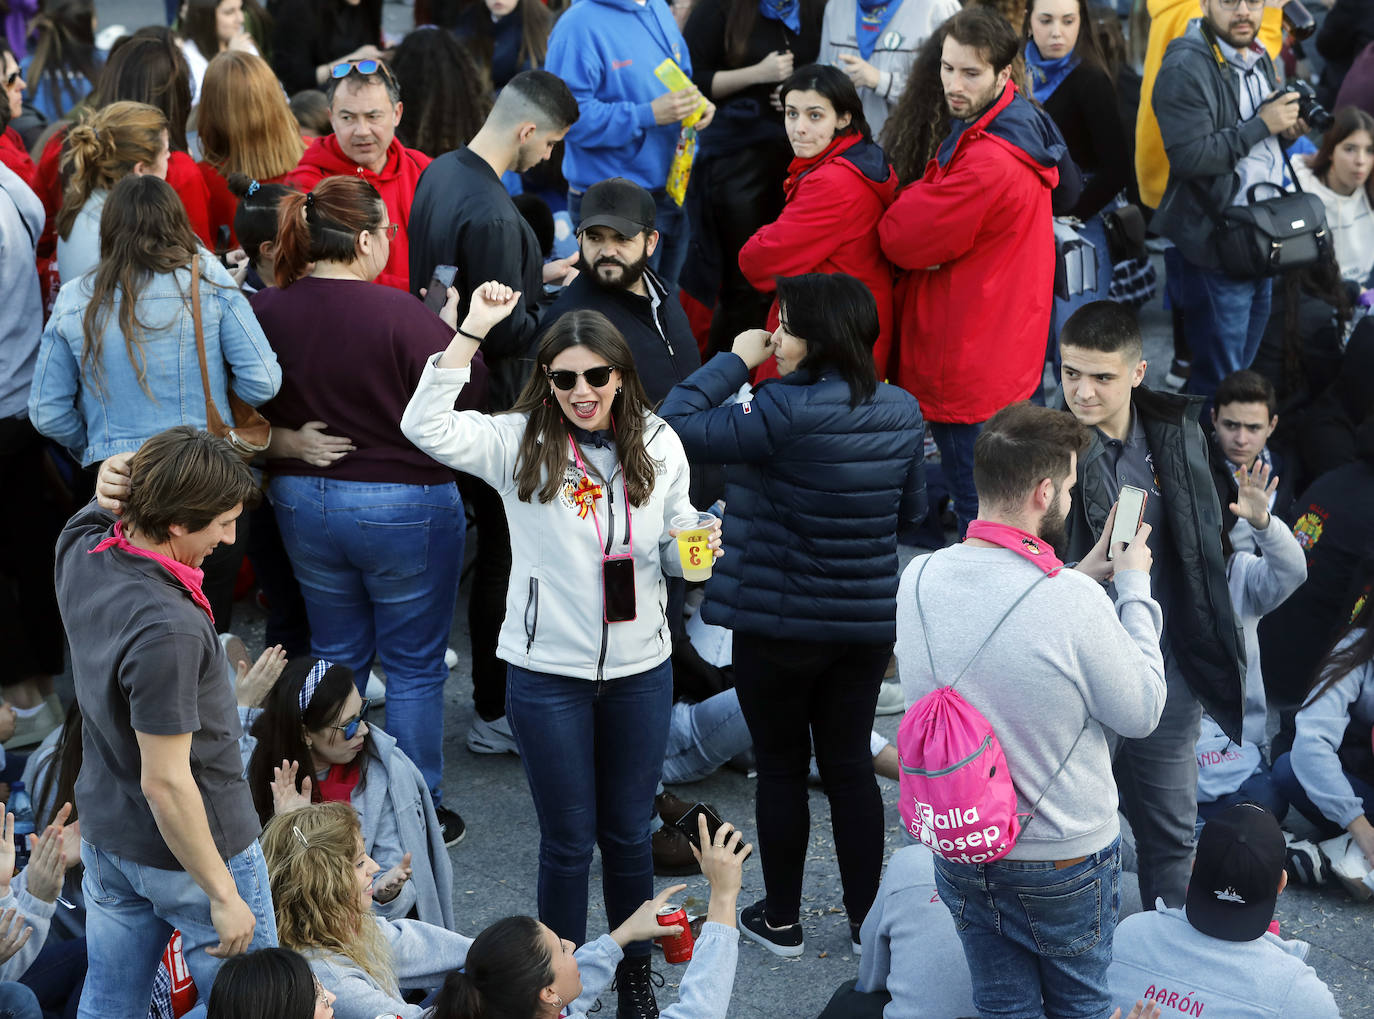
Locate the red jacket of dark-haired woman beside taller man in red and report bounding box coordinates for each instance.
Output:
[739,135,897,380]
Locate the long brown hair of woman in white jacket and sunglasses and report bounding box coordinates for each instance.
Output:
[507,310,654,505]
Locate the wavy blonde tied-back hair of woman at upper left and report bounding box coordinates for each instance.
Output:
[58,102,168,240]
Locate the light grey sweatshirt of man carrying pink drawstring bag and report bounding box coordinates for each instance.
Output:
[896,544,1165,860]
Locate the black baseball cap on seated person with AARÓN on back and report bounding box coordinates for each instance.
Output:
[1187,803,1283,941]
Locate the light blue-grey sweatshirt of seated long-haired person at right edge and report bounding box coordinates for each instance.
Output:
[1289,629,1374,828]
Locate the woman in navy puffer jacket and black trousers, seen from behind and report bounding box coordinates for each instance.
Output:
[660,273,926,956]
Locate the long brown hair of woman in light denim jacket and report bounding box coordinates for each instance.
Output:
[81,174,198,397]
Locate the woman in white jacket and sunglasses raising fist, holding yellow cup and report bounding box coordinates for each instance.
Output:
[401,283,719,1016]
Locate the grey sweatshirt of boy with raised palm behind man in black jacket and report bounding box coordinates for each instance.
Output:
[1197,516,1307,803]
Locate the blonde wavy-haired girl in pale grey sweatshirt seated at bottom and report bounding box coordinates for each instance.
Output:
[262,802,473,1019]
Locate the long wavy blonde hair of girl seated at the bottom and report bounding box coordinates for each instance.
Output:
[262,803,400,997]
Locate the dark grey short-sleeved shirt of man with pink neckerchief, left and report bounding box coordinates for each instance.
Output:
[56,503,261,871]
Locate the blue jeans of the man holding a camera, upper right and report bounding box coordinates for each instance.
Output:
[1179,258,1270,411]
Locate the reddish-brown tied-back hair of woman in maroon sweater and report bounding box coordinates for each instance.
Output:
[276,177,386,288]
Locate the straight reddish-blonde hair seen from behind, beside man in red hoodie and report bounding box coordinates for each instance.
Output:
[196,49,305,180]
